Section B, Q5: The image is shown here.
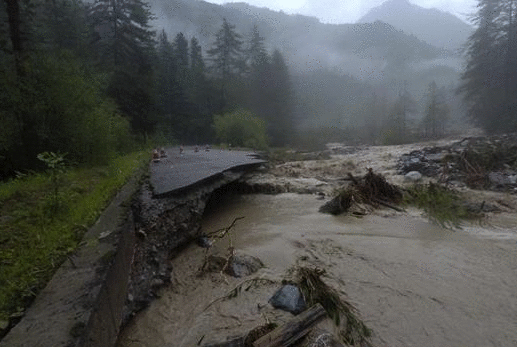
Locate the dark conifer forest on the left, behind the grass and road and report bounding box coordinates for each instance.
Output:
[0,0,292,177]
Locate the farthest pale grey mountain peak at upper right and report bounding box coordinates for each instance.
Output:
[357,0,474,50]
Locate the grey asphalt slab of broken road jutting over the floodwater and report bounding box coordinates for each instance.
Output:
[147,147,266,196]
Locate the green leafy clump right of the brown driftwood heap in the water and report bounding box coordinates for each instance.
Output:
[404,183,479,228]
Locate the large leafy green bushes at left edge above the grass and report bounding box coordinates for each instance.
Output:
[0,51,131,174]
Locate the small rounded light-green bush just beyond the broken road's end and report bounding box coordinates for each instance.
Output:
[214,109,268,150]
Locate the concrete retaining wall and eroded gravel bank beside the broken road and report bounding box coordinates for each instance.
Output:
[0,165,254,347]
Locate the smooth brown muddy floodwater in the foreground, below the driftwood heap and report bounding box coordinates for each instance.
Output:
[119,193,517,347]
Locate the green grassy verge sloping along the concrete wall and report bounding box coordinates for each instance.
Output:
[0,151,149,321]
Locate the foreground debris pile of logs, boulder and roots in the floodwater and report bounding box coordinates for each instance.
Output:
[199,266,371,347]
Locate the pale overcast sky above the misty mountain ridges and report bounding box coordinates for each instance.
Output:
[207,0,477,24]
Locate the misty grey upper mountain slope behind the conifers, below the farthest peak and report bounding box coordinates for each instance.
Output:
[151,0,451,79]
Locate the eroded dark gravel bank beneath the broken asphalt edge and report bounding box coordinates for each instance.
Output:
[122,167,262,324]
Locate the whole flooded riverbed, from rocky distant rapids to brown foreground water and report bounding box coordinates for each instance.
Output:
[119,136,517,347]
